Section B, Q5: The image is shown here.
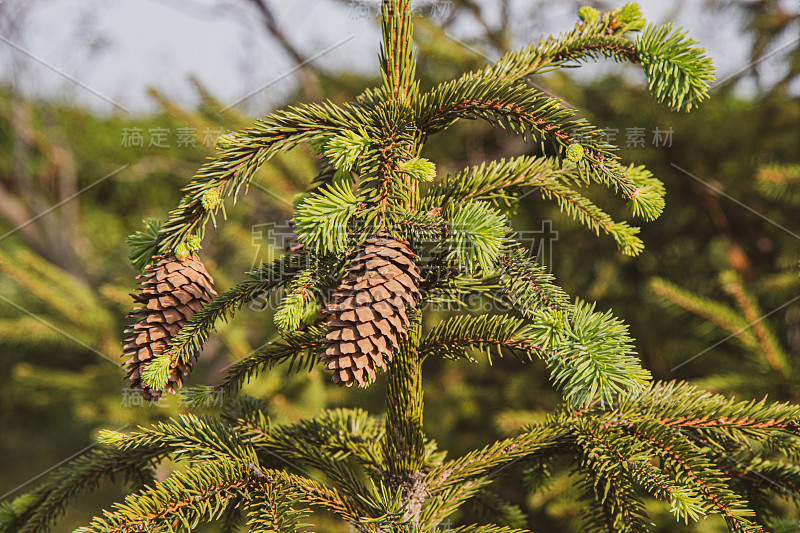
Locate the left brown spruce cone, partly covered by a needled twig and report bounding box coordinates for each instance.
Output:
[123,255,217,401]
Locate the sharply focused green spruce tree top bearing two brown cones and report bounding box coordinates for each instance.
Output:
[6,4,800,533]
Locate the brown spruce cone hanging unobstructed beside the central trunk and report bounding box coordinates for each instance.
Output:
[322,233,420,387]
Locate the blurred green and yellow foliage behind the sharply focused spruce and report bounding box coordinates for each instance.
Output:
[0,0,800,532]
